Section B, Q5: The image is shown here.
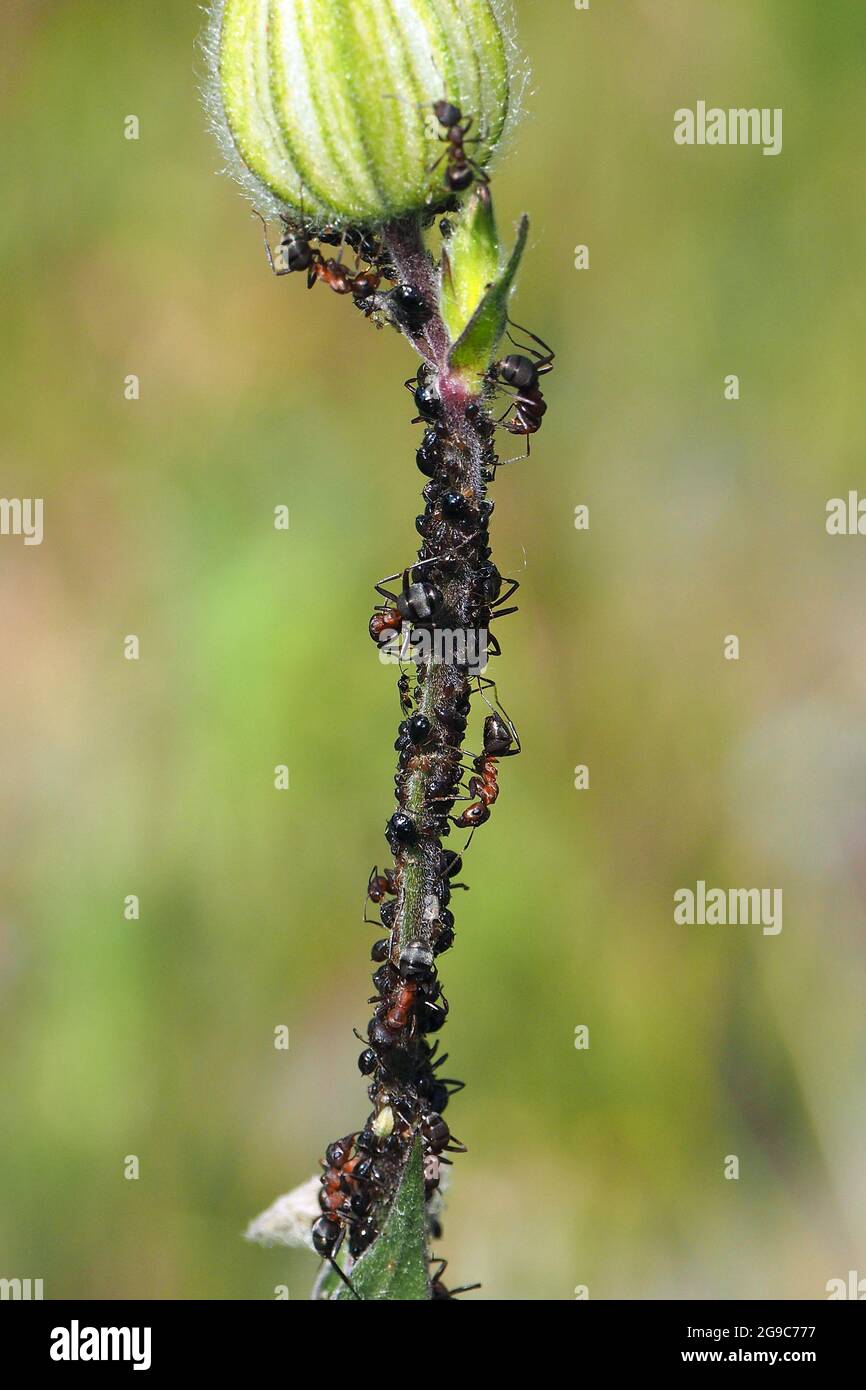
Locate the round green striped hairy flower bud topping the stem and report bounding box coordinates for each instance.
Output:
[206,0,512,227]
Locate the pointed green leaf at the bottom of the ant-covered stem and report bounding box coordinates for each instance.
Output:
[336,1138,430,1302]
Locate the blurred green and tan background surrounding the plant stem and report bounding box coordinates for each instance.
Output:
[0,0,866,1300]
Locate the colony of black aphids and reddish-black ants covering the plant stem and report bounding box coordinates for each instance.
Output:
[257,101,553,1300]
